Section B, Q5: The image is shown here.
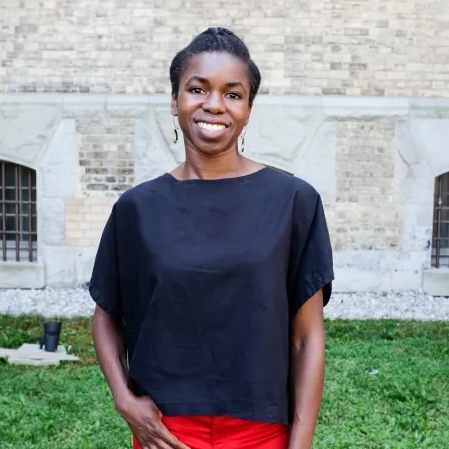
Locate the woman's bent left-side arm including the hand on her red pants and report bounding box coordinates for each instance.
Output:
[92,306,189,449]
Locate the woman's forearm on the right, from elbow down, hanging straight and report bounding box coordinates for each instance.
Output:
[289,332,324,449]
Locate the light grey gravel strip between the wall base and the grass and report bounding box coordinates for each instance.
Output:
[0,288,449,321]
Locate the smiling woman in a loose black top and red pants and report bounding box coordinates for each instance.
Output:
[90,28,333,449]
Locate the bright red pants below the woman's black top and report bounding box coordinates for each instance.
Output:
[133,416,288,449]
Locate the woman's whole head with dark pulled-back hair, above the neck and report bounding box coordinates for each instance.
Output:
[170,28,261,168]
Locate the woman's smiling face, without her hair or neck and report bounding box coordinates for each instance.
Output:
[172,52,251,154]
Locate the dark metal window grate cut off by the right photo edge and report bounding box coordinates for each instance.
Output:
[432,173,449,268]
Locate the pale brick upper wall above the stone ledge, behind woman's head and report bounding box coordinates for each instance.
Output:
[0,0,449,97]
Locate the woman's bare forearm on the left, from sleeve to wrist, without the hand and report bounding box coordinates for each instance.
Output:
[92,307,130,401]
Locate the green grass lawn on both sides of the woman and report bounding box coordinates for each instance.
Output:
[0,316,449,449]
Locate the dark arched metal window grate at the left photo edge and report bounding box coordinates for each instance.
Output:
[0,161,37,262]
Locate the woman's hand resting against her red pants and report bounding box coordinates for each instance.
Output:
[115,394,190,449]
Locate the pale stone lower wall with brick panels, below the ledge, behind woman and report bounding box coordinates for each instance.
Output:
[0,94,449,294]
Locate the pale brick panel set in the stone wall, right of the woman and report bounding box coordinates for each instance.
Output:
[328,120,404,251]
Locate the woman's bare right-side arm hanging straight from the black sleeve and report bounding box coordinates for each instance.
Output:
[288,290,324,449]
